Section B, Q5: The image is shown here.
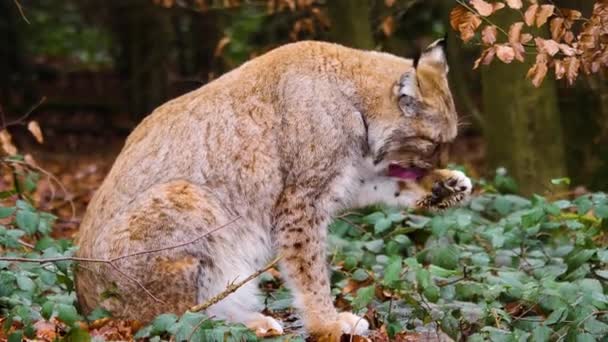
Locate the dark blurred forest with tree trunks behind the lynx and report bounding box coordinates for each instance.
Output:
[0,0,608,193]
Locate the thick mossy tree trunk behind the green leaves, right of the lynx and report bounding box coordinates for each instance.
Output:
[482,11,567,194]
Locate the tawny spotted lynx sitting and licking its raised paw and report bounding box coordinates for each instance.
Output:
[76,42,471,340]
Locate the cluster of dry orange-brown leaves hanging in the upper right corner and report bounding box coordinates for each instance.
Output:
[450,0,608,87]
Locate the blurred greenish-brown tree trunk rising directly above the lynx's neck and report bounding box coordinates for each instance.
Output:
[327,0,375,50]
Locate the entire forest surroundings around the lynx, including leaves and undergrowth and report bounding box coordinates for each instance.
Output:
[0,0,608,342]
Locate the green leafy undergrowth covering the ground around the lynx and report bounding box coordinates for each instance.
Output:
[0,157,608,342]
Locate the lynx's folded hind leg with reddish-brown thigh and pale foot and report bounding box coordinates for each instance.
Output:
[77,180,280,331]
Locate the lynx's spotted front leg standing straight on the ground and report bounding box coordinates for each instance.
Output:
[275,187,369,341]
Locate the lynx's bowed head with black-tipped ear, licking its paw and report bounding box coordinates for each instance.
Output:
[369,40,458,179]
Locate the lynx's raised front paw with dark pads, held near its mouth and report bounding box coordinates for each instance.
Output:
[417,170,473,209]
